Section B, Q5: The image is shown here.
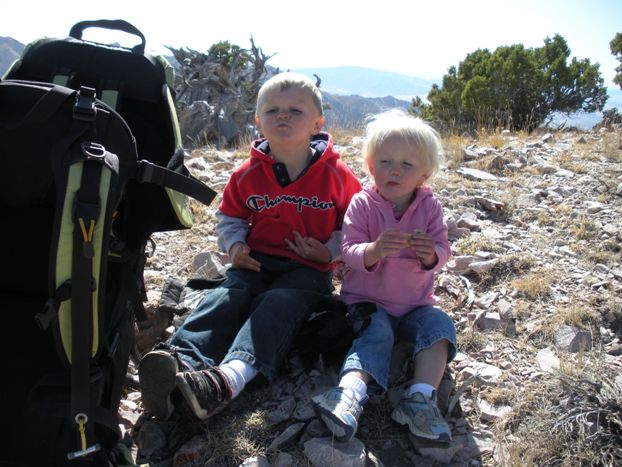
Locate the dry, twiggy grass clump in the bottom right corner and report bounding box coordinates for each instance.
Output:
[497,364,622,467]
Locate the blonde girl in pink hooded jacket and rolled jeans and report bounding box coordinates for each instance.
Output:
[313,111,456,442]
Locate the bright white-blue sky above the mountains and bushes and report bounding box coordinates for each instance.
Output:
[0,0,622,88]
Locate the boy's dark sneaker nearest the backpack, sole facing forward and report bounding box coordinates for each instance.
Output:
[138,350,181,420]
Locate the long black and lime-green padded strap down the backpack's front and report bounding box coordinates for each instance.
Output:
[50,87,119,457]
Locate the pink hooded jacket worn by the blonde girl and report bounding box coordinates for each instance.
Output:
[341,186,451,316]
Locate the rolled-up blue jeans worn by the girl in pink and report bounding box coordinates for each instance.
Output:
[341,305,457,391]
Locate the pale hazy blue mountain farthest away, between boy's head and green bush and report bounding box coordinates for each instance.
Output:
[291,66,440,101]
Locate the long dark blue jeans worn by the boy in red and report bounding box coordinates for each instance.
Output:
[170,253,333,380]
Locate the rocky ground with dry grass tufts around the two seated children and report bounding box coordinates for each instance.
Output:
[120,129,622,467]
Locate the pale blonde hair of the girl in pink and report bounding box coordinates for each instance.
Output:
[362,109,445,180]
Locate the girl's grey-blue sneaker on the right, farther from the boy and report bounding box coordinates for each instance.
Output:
[391,391,451,443]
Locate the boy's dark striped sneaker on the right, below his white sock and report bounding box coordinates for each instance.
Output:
[176,366,233,420]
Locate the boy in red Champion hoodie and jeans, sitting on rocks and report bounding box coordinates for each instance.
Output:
[138,73,361,420]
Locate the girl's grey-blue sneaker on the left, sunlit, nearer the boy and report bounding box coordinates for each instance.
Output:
[311,387,368,442]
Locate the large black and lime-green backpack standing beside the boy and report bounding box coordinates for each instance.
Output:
[0,20,216,467]
